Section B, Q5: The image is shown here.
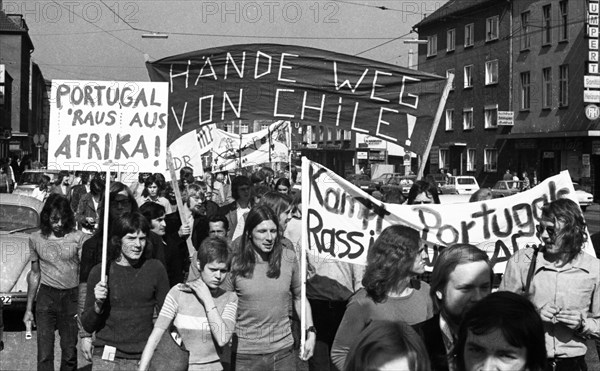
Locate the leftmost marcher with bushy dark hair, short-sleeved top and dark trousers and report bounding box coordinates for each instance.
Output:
[23,193,89,370]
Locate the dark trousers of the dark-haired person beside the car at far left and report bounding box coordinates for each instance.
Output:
[35,285,78,371]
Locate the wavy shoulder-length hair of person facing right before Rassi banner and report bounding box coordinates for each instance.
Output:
[362,225,419,303]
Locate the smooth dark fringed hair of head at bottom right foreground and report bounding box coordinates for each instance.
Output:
[455,291,547,371]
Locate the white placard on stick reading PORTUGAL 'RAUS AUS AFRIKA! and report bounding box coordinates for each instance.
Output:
[48,80,168,172]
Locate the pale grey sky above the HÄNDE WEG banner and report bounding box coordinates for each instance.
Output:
[3,0,446,81]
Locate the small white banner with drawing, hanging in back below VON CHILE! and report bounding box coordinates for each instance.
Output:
[212,121,289,171]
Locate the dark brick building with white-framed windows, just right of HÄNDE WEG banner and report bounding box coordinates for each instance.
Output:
[415,0,511,185]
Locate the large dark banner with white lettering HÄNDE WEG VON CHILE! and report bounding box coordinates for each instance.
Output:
[146,44,447,155]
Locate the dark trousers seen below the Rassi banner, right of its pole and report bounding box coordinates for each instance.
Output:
[308,299,348,371]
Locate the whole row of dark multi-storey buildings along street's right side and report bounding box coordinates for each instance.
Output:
[415,0,600,199]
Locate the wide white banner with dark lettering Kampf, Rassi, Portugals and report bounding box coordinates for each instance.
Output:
[302,158,595,273]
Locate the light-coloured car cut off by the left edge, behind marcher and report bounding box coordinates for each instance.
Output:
[0,194,43,310]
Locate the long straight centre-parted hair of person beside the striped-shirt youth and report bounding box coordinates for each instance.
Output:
[231,205,283,278]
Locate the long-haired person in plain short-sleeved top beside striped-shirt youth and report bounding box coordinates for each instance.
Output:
[224,205,316,370]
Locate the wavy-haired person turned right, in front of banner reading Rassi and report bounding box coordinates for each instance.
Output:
[331,225,433,370]
